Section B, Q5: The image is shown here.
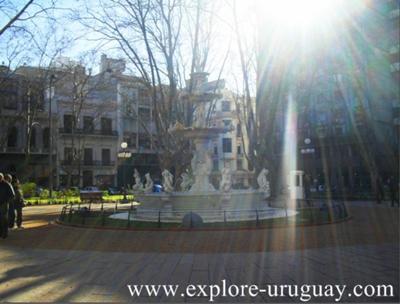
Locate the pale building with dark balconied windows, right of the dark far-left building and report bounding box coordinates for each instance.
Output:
[52,59,119,188]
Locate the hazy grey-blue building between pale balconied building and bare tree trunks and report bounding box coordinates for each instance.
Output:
[100,55,160,186]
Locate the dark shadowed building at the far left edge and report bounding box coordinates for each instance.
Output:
[0,66,55,185]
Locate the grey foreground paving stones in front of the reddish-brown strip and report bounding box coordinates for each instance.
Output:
[0,244,399,302]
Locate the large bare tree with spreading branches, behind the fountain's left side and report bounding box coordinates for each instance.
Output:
[75,0,219,176]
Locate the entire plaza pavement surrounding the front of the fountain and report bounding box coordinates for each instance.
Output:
[0,202,399,303]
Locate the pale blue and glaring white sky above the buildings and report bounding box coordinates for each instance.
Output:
[0,0,359,92]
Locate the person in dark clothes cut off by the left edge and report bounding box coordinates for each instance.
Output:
[0,173,15,239]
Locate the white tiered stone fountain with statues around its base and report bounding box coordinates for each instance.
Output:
[109,72,295,222]
